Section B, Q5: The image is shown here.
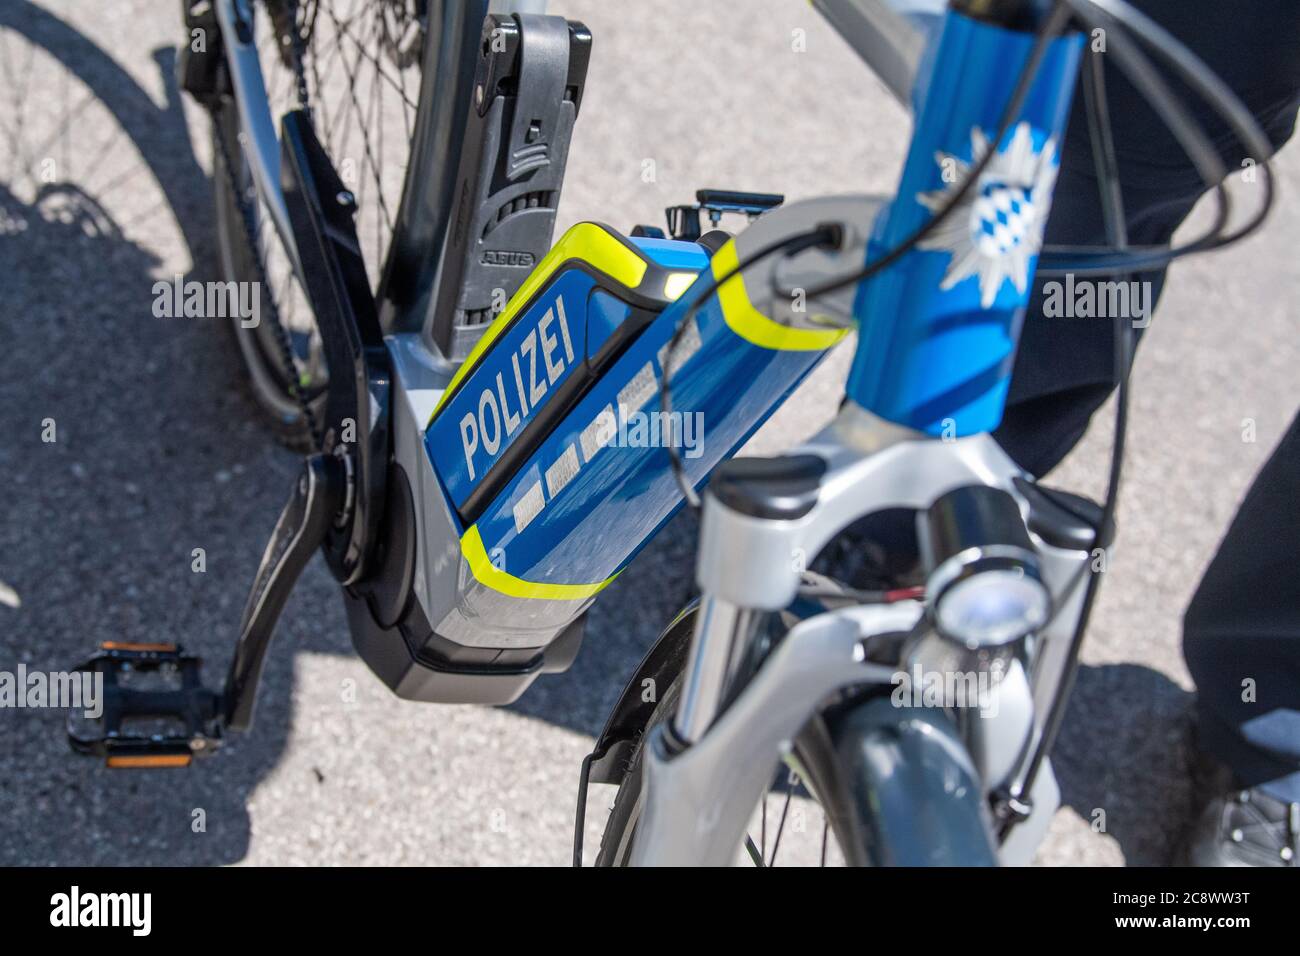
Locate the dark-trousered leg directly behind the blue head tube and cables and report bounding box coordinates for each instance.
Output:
[995,0,1300,477]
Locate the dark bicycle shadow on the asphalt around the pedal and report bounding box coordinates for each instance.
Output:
[0,0,350,865]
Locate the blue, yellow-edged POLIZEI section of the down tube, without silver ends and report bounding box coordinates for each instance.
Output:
[424,222,846,606]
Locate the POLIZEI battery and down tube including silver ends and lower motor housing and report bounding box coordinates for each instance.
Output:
[350,198,875,704]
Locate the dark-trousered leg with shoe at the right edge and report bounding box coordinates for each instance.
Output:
[1183,415,1300,865]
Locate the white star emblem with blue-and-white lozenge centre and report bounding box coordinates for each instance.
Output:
[917,122,1057,308]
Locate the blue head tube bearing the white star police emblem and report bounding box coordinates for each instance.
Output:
[848,3,1083,437]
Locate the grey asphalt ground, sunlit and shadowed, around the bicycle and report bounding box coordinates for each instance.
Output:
[0,0,1300,865]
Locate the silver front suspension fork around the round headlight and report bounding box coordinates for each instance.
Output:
[632,405,1091,865]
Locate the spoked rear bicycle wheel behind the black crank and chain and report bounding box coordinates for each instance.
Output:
[212,0,425,450]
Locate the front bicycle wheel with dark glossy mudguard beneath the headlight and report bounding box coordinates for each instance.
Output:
[595,613,997,866]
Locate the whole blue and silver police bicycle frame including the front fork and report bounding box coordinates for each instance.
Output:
[218,0,1091,864]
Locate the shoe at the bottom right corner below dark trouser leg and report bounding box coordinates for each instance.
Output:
[1186,767,1300,866]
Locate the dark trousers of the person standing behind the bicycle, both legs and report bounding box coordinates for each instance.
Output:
[996,0,1300,801]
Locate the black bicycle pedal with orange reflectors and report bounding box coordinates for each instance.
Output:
[68,641,222,767]
